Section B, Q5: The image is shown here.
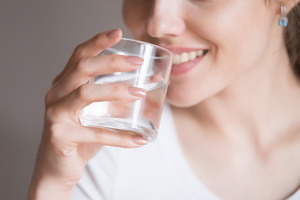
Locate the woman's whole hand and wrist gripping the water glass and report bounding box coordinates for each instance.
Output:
[29,29,147,200]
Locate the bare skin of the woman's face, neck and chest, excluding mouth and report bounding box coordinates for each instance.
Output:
[123,0,300,199]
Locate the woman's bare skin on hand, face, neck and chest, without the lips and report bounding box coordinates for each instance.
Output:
[29,0,300,200]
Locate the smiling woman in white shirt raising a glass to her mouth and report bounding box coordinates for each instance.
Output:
[29,0,300,200]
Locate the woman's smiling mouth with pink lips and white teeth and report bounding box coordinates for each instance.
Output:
[164,47,208,75]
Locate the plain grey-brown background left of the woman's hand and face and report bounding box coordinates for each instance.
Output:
[0,0,130,200]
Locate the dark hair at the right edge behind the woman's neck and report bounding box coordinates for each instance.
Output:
[284,2,300,80]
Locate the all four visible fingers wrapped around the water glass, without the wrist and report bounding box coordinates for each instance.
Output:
[45,29,147,152]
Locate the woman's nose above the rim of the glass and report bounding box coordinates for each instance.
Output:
[146,0,185,38]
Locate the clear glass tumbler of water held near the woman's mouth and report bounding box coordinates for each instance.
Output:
[81,38,172,142]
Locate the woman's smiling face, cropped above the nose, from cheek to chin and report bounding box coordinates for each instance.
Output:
[123,0,280,107]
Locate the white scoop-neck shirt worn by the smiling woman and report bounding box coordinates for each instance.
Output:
[72,106,300,200]
